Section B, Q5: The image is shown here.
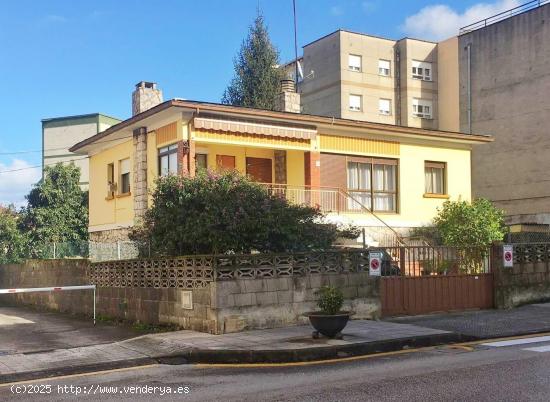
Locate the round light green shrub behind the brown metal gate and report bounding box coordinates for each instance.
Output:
[434,198,505,247]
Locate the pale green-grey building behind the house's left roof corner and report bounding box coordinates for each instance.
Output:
[42,113,120,190]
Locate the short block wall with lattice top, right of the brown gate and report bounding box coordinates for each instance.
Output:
[492,244,550,308]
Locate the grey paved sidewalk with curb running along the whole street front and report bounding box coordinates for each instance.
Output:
[0,303,550,383]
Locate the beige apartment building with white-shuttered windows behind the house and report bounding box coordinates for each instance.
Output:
[283,30,459,131]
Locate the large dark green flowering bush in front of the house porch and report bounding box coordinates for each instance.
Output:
[131,171,359,255]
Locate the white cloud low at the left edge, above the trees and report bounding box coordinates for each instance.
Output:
[0,159,42,207]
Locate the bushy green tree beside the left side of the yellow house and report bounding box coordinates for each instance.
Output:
[20,163,88,245]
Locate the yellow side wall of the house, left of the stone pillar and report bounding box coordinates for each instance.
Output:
[89,140,134,231]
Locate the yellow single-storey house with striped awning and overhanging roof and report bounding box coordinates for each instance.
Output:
[71,90,492,242]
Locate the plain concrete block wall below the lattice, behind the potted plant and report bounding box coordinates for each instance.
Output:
[212,272,381,333]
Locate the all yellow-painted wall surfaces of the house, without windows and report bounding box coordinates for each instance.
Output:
[90,121,471,230]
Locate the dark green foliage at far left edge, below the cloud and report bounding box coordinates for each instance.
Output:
[0,206,27,264]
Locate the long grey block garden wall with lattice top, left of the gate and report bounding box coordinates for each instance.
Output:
[0,251,381,334]
